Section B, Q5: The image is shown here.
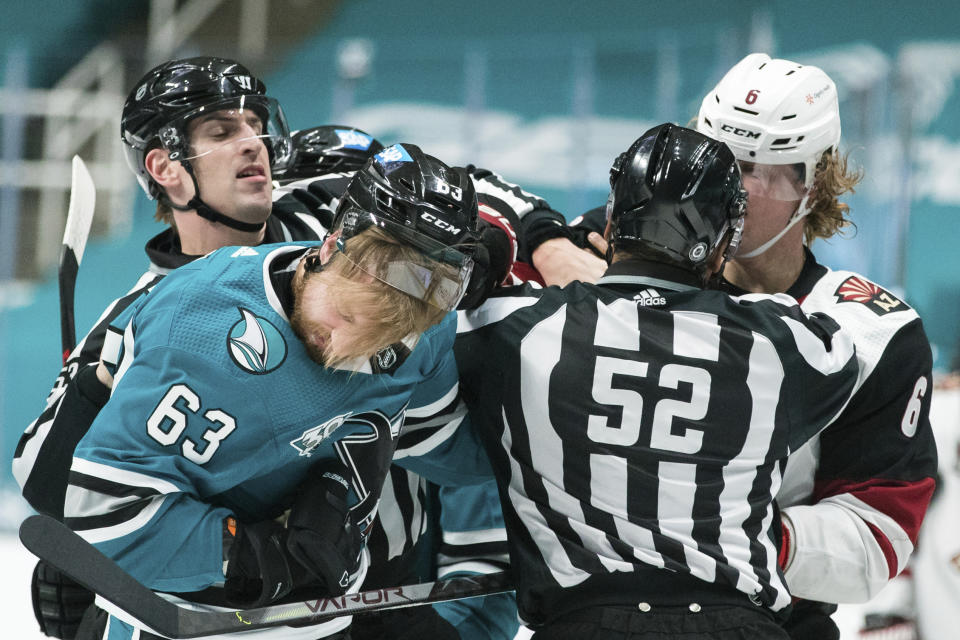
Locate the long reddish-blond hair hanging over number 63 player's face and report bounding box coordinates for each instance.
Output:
[306,228,447,366]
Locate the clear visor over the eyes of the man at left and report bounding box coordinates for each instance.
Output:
[160,96,293,171]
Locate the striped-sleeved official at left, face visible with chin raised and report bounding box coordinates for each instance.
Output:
[13,57,312,517]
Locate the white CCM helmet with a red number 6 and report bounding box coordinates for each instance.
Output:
[697,53,840,189]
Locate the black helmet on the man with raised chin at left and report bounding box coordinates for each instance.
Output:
[120,56,291,208]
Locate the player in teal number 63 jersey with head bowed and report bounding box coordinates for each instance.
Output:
[64,145,496,639]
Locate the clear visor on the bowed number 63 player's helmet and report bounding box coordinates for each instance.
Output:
[332,208,474,311]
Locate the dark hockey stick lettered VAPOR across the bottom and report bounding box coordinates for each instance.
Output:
[20,515,514,638]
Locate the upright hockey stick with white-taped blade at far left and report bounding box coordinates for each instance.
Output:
[57,156,97,362]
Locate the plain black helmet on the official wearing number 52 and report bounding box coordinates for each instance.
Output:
[607,123,746,276]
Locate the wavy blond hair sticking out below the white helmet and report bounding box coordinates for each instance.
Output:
[803,149,863,245]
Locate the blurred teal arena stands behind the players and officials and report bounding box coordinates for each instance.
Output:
[0,0,960,636]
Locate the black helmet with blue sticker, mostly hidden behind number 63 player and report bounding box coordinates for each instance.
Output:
[274,124,383,183]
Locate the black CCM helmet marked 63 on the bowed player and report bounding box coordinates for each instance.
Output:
[331,144,486,309]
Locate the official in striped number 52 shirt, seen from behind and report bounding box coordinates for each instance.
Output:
[456,125,858,640]
